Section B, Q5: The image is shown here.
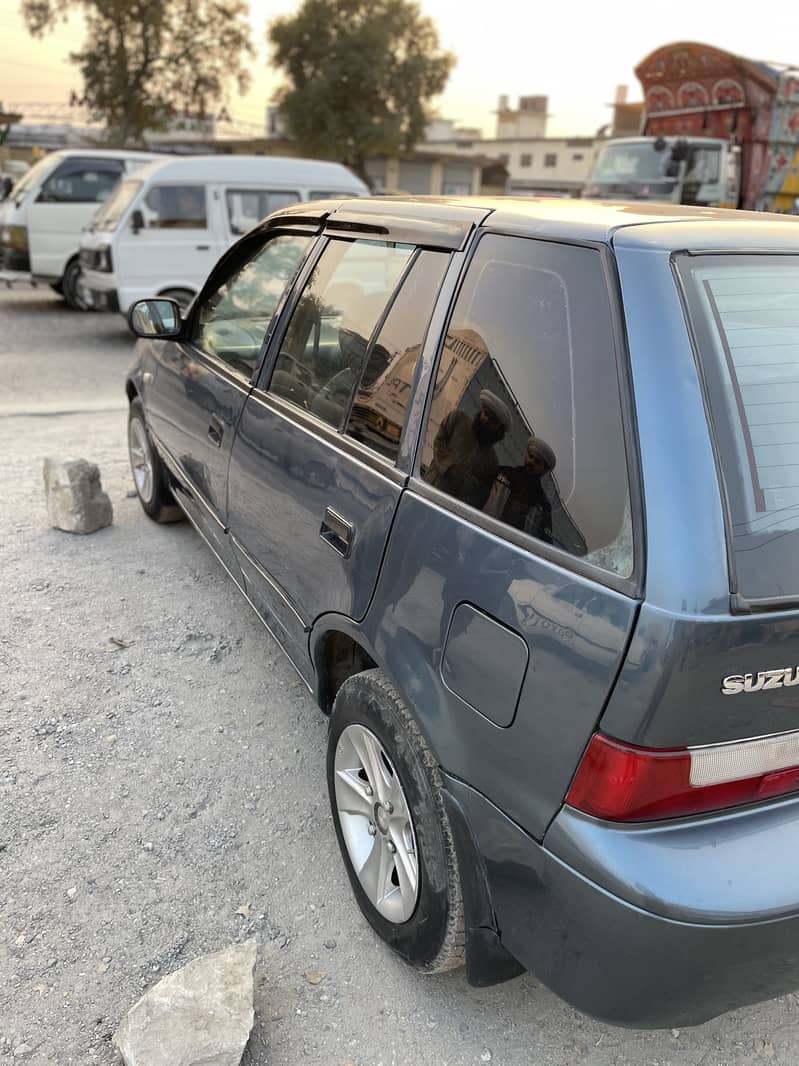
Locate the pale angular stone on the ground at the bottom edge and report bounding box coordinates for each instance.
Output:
[113,940,256,1066]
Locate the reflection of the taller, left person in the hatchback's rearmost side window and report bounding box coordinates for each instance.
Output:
[425,389,510,507]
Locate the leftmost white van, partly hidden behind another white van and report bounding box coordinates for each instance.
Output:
[0,148,168,310]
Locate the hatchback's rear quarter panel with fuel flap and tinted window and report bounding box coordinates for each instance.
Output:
[363,233,640,839]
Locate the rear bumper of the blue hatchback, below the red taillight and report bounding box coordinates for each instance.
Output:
[447,780,799,1029]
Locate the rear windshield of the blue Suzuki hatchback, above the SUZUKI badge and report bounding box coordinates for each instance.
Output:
[678,248,799,603]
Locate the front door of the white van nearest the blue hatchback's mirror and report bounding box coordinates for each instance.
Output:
[114,181,224,311]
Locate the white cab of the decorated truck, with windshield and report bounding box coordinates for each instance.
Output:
[584,136,740,207]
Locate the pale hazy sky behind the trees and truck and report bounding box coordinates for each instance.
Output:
[0,0,799,138]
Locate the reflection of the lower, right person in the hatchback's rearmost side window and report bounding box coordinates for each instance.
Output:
[485,437,555,544]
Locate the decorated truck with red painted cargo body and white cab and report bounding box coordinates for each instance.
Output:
[584,44,799,213]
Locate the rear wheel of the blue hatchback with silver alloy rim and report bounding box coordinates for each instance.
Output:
[327,669,463,973]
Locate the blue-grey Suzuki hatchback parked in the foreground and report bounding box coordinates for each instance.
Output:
[127,197,799,1028]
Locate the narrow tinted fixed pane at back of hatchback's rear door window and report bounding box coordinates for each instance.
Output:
[346,252,450,459]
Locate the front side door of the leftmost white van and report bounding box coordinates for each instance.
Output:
[27,156,125,280]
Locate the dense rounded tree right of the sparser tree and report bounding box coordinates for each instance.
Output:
[267,0,455,180]
